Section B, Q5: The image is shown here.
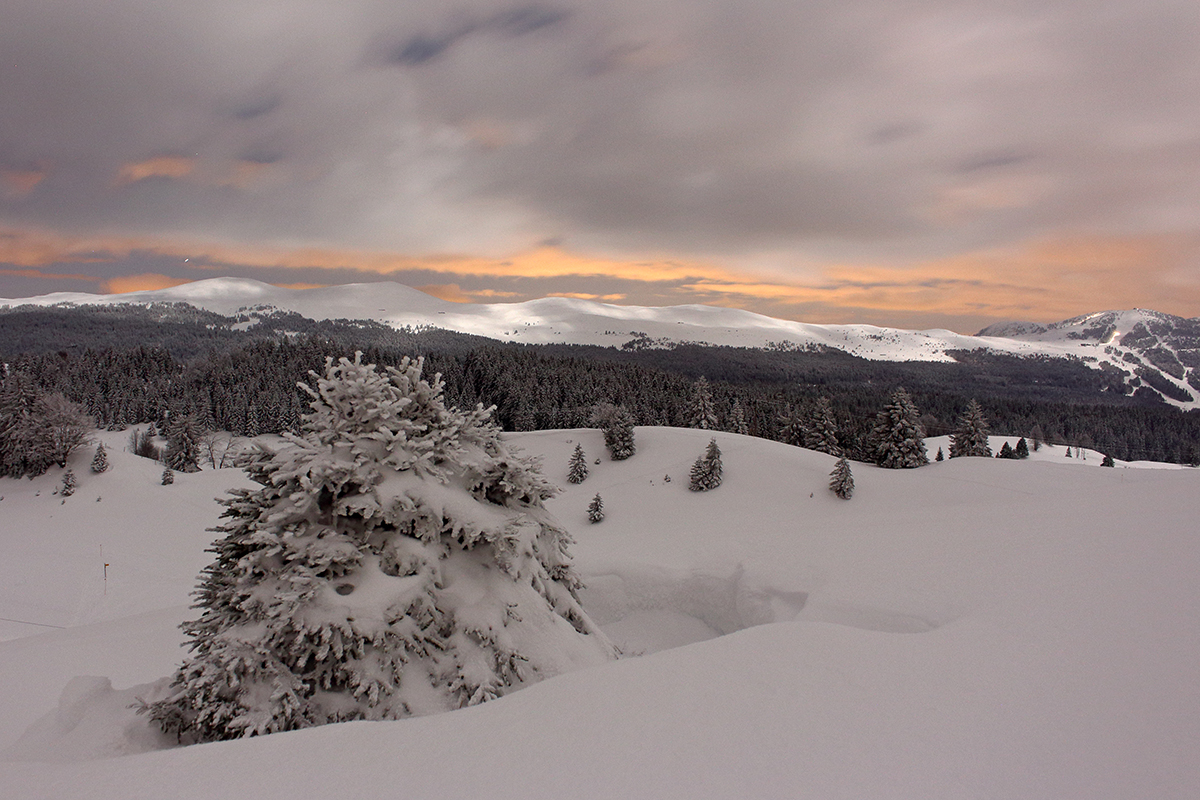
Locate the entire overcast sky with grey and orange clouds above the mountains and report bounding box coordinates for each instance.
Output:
[0,0,1200,332]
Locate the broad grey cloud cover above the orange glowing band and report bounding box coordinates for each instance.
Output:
[0,0,1200,268]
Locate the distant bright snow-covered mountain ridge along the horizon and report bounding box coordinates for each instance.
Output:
[0,278,1200,408]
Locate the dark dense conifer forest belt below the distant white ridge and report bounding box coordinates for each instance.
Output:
[8,316,1200,463]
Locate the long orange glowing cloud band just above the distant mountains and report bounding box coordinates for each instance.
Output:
[0,225,1200,324]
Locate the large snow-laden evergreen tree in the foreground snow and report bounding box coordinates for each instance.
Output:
[144,356,614,741]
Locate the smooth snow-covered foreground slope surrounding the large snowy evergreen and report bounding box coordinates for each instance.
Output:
[0,428,1200,800]
